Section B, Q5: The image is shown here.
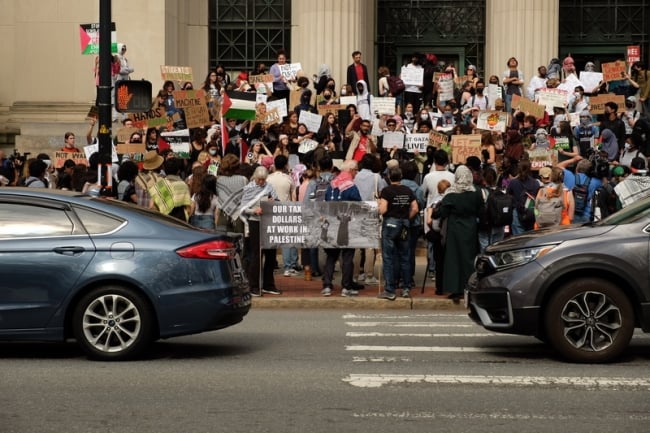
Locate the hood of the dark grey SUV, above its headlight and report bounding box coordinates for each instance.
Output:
[486,224,615,253]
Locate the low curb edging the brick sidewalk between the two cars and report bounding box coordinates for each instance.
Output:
[252,295,467,312]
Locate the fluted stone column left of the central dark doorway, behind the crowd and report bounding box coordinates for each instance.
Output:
[290,0,377,93]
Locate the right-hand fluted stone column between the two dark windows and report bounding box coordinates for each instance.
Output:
[485,0,560,96]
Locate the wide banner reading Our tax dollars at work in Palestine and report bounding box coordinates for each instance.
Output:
[260,200,380,248]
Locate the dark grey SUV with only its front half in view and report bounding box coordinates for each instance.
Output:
[465,199,650,363]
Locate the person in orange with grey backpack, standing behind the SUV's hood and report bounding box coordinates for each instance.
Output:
[535,167,575,229]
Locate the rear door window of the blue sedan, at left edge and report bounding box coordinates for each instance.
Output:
[0,203,74,239]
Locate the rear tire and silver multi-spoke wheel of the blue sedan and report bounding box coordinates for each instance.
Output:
[73,286,154,361]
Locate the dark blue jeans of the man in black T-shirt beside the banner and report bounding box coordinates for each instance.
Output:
[381,217,414,293]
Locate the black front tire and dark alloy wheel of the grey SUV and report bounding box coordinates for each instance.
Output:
[544,278,635,363]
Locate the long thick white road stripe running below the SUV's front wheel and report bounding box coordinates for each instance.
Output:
[343,374,650,390]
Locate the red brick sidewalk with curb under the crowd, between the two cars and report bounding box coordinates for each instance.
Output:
[248,252,466,311]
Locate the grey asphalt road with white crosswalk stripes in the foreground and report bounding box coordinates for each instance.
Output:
[0,310,650,433]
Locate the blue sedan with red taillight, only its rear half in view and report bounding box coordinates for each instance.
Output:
[0,187,251,360]
